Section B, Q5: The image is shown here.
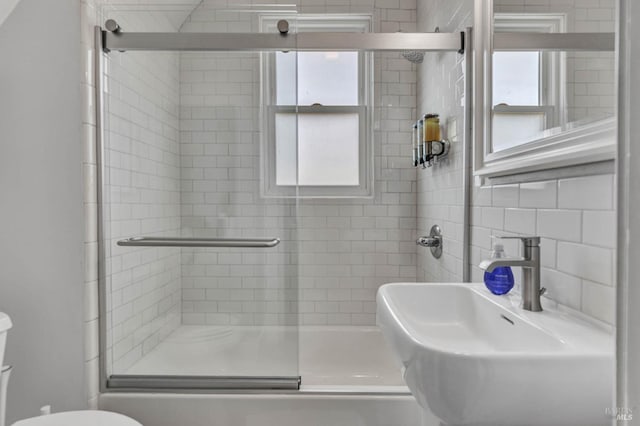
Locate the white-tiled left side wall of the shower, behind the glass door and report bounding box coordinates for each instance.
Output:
[83,3,181,378]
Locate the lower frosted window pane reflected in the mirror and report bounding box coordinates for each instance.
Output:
[492,112,545,152]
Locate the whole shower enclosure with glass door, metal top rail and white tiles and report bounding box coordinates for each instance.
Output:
[95,1,465,392]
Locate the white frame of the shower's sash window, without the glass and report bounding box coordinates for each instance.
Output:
[260,14,374,198]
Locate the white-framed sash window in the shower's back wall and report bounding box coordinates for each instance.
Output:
[262,15,373,198]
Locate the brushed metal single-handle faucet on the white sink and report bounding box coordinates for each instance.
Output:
[479,237,546,312]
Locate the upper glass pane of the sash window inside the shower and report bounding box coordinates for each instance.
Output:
[276,52,358,105]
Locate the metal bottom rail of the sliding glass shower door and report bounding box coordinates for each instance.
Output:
[107,375,301,392]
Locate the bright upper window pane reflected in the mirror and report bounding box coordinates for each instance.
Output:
[493,52,540,106]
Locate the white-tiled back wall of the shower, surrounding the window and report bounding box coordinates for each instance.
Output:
[180,0,416,325]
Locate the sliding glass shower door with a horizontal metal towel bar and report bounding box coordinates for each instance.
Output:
[101,9,299,389]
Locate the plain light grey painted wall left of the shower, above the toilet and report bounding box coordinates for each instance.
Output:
[0,0,86,424]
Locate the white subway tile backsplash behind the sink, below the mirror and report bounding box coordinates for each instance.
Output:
[471,174,616,325]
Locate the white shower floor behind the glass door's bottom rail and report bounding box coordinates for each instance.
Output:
[125,325,409,394]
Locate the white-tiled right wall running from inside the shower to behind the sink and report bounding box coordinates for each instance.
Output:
[418,0,615,326]
